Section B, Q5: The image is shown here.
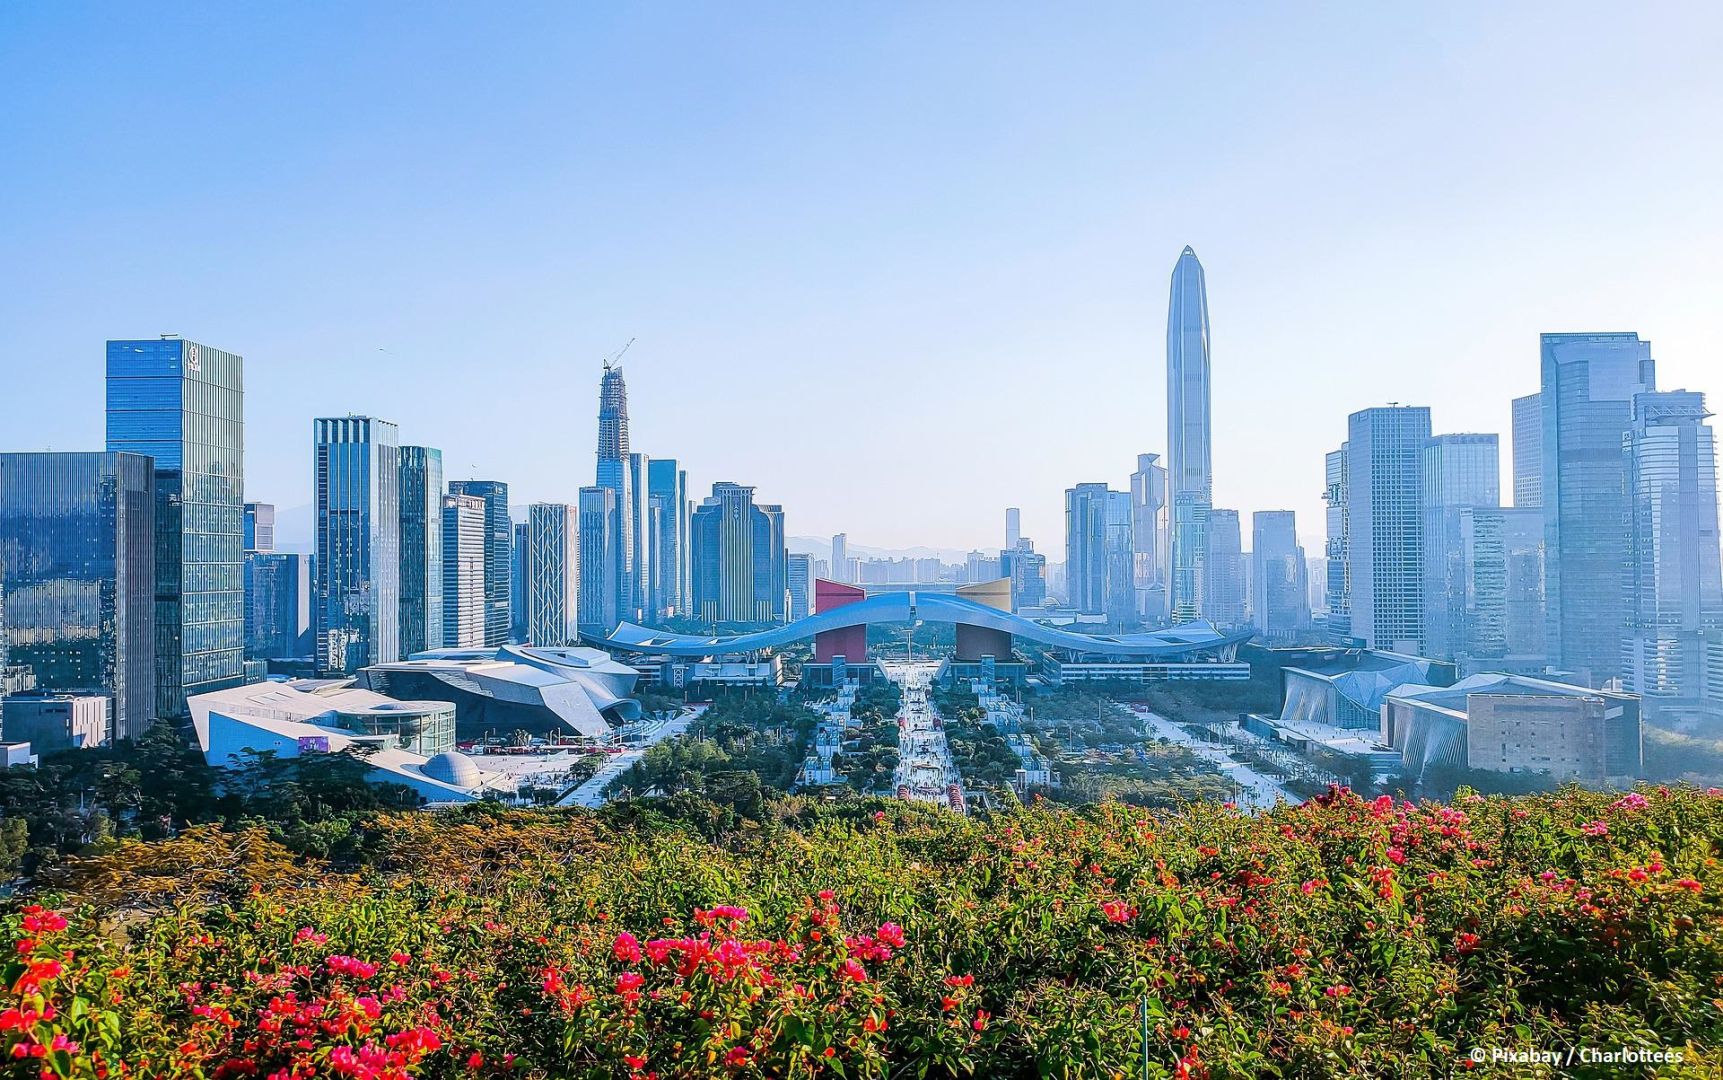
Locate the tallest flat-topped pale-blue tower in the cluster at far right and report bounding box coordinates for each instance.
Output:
[1540,334,1658,687]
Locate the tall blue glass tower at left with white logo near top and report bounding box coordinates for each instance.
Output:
[107,338,245,717]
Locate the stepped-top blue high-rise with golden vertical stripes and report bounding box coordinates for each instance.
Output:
[691,482,789,624]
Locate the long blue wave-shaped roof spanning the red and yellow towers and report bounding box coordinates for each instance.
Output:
[591,591,1253,660]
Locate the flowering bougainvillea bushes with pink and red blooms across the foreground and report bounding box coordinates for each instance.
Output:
[0,789,1723,1080]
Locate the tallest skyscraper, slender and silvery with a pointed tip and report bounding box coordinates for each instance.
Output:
[1166,248,1215,622]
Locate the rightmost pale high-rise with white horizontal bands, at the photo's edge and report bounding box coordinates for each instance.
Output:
[1623,389,1723,718]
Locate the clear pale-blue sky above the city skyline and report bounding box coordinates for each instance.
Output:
[0,0,1723,560]
